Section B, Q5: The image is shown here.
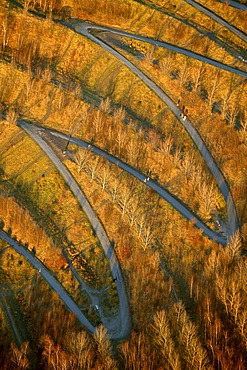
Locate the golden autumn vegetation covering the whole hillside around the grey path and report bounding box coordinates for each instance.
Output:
[0,0,247,370]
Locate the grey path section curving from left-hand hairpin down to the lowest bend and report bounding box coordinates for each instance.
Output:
[18,121,131,339]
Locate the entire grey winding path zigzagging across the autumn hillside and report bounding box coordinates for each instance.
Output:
[0,10,241,339]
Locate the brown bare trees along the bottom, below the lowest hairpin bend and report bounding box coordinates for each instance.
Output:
[2,223,246,369]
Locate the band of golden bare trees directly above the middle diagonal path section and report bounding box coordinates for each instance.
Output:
[2,53,226,225]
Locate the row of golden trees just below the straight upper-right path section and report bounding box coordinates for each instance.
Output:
[116,33,246,128]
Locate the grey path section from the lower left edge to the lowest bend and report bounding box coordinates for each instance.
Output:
[0,230,95,333]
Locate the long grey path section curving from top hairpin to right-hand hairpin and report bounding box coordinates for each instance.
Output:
[72,22,239,243]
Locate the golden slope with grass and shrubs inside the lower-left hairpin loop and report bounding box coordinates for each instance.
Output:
[0,130,117,310]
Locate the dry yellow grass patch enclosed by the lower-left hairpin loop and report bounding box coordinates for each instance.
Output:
[0,128,114,294]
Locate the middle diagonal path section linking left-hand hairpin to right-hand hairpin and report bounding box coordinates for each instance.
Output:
[39,125,227,246]
